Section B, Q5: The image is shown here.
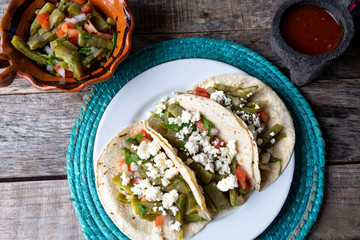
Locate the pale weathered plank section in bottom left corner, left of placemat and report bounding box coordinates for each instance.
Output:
[0,180,84,240]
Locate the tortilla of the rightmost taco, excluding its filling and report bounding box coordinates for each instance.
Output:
[188,74,295,191]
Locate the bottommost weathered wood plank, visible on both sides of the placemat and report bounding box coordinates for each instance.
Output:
[0,164,360,239]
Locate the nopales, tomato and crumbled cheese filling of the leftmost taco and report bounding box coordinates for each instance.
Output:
[112,127,206,239]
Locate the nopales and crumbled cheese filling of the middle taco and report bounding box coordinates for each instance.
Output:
[154,101,251,211]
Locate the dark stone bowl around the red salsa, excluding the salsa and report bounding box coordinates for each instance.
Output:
[270,0,354,86]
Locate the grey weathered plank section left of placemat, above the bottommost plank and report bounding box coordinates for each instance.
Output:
[0,92,87,178]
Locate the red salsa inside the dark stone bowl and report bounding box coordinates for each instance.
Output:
[280,5,343,55]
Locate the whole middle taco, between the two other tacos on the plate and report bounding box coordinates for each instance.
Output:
[148,94,258,217]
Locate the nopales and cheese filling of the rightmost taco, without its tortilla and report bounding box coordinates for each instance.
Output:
[196,83,286,176]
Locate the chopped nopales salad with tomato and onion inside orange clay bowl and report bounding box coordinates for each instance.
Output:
[11,0,116,78]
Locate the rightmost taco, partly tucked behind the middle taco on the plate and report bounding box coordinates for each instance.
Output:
[188,74,295,190]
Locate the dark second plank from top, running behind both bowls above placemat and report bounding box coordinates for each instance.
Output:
[0,30,360,95]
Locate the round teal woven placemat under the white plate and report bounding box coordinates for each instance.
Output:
[67,38,325,239]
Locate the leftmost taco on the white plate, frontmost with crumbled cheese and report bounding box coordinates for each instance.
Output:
[95,122,211,240]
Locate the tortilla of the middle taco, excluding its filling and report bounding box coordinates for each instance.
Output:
[148,94,260,217]
